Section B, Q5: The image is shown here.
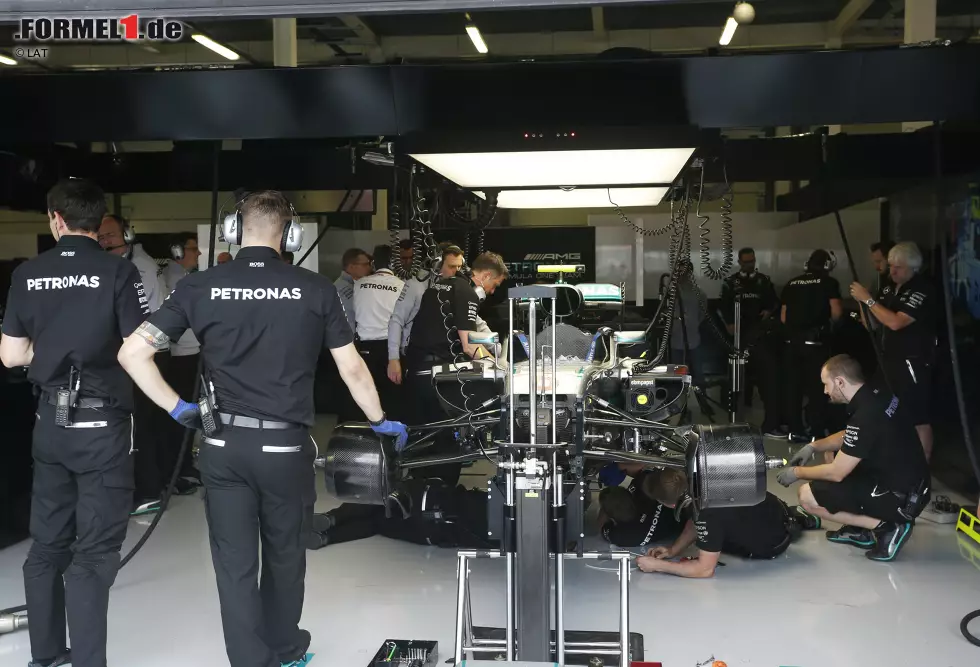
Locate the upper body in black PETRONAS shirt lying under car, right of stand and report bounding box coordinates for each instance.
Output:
[598,463,681,547]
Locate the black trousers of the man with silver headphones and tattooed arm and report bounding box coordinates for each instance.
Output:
[199,426,316,667]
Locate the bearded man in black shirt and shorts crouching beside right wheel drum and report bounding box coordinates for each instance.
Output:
[777,354,931,562]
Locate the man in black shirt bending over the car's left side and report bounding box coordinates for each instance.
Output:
[405,252,507,485]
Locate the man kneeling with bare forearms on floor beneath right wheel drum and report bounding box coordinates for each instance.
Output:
[636,470,820,579]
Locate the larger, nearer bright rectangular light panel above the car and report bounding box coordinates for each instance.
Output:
[412,148,694,188]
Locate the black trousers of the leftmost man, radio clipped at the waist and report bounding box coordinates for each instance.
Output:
[24,401,133,667]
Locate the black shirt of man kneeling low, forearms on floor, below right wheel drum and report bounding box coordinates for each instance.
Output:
[694,493,786,556]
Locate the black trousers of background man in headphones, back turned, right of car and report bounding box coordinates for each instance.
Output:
[783,340,828,438]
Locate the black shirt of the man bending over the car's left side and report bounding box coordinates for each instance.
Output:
[405,276,480,365]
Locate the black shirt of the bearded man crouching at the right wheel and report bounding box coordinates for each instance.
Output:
[841,384,929,492]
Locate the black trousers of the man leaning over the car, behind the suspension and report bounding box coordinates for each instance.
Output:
[405,361,475,486]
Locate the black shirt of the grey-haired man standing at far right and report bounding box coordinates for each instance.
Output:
[880,275,937,359]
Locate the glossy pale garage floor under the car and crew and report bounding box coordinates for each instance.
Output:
[0,420,980,667]
